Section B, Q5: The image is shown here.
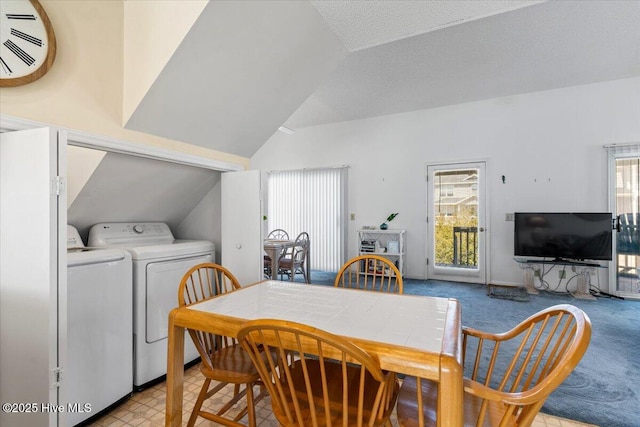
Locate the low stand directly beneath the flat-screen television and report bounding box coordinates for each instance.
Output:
[515,258,606,300]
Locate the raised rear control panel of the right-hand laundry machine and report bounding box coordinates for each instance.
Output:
[88,222,174,247]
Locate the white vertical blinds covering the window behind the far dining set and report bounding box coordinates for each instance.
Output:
[267,167,348,271]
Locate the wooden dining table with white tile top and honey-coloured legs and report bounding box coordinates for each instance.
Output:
[165,280,463,427]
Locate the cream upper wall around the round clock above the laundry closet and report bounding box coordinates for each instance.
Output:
[0,0,249,171]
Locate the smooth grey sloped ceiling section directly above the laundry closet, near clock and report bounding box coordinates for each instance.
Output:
[126,1,347,157]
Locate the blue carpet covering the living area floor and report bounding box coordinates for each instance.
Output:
[302,271,640,427]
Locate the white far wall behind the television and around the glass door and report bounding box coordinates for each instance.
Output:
[251,78,640,290]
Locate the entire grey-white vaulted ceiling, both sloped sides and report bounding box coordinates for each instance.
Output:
[126,0,640,157]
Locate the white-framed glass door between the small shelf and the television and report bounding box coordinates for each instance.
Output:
[427,162,489,283]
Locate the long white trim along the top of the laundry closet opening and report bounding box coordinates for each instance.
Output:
[0,114,244,172]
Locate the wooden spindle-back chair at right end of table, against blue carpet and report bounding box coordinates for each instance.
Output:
[397,304,591,427]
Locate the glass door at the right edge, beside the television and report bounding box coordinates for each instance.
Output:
[610,153,640,298]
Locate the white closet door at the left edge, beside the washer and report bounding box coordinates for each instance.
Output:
[0,128,67,426]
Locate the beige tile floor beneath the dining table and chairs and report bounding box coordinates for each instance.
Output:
[90,365,594,427]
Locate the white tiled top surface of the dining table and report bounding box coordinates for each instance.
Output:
[189,280,449,353]
